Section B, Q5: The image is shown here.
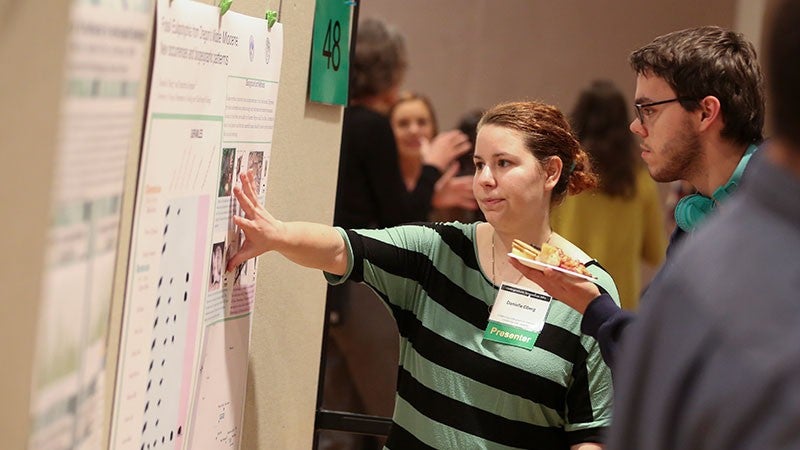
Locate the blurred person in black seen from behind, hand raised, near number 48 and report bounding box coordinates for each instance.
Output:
[334,19,471,228]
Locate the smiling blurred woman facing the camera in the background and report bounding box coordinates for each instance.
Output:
[389,92,478,221]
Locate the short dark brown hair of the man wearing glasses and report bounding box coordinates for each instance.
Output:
[630,26,764,144]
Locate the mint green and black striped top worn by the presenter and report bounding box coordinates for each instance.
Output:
[326,223,618,450]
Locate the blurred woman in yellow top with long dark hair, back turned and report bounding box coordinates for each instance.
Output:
[553,80,666,309]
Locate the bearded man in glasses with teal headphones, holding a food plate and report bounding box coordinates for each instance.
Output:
[511,26,764,368]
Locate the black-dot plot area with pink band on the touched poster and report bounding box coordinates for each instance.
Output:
[112,196,210,449]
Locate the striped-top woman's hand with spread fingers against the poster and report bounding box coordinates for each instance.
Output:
[227,170,283,270]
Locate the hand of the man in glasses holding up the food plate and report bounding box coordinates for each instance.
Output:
[509,257,600,314]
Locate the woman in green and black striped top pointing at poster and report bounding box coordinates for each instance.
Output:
[229,102,616,450]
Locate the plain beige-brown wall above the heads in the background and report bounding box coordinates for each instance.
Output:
[361,0,747,129]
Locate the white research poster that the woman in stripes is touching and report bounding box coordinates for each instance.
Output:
[111,0,283,450]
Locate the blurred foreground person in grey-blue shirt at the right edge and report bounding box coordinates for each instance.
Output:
[608,0,800,450]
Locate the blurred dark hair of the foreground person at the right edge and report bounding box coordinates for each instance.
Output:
[765,0,800,151]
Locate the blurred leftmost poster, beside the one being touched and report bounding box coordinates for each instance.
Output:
[29,0,153,450]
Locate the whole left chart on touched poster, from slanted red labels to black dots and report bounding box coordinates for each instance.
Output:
[112,115,221,449]
